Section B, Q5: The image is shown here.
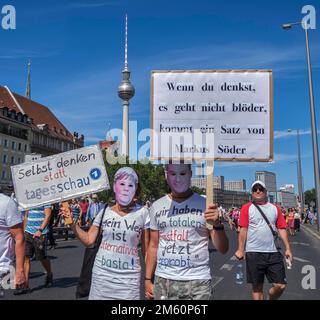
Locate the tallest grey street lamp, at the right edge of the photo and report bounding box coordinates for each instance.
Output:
[282,22,320,232]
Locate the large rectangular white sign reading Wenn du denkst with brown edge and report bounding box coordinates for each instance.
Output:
[151,70,273,161]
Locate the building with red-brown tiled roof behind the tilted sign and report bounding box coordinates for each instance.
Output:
[0,86,84,192]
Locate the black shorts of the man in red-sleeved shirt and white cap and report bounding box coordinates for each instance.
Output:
[246,252,287,285]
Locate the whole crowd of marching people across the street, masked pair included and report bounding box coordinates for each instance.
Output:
[0,163,315,300]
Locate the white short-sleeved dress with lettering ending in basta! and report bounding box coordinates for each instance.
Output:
[91,206,150,298]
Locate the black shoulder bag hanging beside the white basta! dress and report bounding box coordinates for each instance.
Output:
[76,204,108,299]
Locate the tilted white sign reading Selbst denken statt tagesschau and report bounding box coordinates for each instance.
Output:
[11,145,109,209]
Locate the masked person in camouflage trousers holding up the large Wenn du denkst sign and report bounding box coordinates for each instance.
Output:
[145,164,228,300]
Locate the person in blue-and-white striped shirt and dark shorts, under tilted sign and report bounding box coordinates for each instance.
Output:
[24,206,53,293]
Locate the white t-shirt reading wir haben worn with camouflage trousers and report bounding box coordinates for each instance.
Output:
[150,193,211,280]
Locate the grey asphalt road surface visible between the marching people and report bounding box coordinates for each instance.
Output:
[5,225,320,300]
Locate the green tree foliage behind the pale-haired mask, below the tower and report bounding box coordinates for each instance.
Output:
[99,152,170,204]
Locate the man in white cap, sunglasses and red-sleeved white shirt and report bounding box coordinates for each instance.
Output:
[235,180,292,300]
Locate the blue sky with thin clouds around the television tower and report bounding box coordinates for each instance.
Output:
[0,0,320,189]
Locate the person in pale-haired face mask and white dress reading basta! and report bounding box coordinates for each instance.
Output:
[65,167,149,300]
